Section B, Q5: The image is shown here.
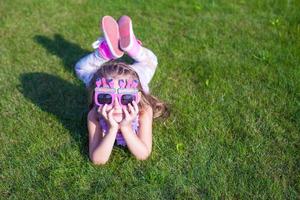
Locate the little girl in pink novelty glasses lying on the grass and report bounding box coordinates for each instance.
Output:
[75,16,166,164]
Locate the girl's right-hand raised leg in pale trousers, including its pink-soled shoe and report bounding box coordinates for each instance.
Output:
[118,16,157,93]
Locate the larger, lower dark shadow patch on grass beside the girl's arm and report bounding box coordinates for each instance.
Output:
[20,73,88,156]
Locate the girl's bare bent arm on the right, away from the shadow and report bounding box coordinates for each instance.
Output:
[121,106,153,160]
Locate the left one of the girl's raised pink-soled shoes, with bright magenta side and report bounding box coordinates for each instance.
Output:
[98,16,124,59]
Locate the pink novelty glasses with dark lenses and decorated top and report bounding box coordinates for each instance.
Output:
[94,78,138,106]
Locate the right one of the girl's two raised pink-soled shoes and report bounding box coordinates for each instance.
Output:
[118,15,142,59]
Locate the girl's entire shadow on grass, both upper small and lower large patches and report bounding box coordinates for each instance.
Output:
[20,34,88,156]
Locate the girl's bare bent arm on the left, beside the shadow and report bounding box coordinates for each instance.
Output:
[88,107,117,165]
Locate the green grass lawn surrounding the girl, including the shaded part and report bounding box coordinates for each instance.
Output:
[0,0,300,199]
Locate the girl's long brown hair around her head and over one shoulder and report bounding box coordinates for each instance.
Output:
[88,61,169,118]
